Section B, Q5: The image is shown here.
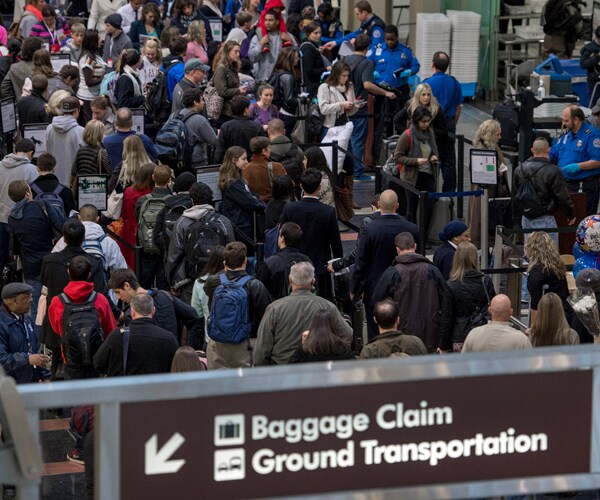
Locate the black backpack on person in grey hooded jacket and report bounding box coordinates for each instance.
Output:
[183,213,227,276]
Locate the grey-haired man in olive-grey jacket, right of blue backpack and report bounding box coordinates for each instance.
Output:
[254,262,352,366]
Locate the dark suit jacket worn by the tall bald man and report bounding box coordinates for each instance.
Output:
[353,214,419,304]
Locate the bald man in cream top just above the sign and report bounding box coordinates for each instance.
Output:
[462,294,532,352]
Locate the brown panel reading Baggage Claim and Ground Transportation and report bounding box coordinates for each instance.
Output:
[121,370,592,499]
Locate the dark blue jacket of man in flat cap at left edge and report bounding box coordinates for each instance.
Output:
[0,304,50,384]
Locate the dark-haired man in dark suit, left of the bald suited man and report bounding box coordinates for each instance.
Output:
[280,168,343,299]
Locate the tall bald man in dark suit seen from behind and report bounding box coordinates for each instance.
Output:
[352,189,419,339]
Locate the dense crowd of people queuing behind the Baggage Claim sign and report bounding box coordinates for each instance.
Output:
[0,0,600,492]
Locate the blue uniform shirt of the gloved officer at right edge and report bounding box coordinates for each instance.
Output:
[550,123,600,167]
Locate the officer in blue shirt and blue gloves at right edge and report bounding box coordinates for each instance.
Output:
[550,104,600,215]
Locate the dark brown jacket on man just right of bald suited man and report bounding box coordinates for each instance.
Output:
[373,253,446,352]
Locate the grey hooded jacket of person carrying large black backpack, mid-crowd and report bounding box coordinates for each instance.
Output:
[165,205,235,289]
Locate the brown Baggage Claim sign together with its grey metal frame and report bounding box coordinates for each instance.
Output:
[7,346,600,500]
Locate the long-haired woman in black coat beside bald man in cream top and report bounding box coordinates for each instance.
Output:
[441,242,496,352]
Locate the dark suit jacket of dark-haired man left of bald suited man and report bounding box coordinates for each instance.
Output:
[280,197,344,275]
